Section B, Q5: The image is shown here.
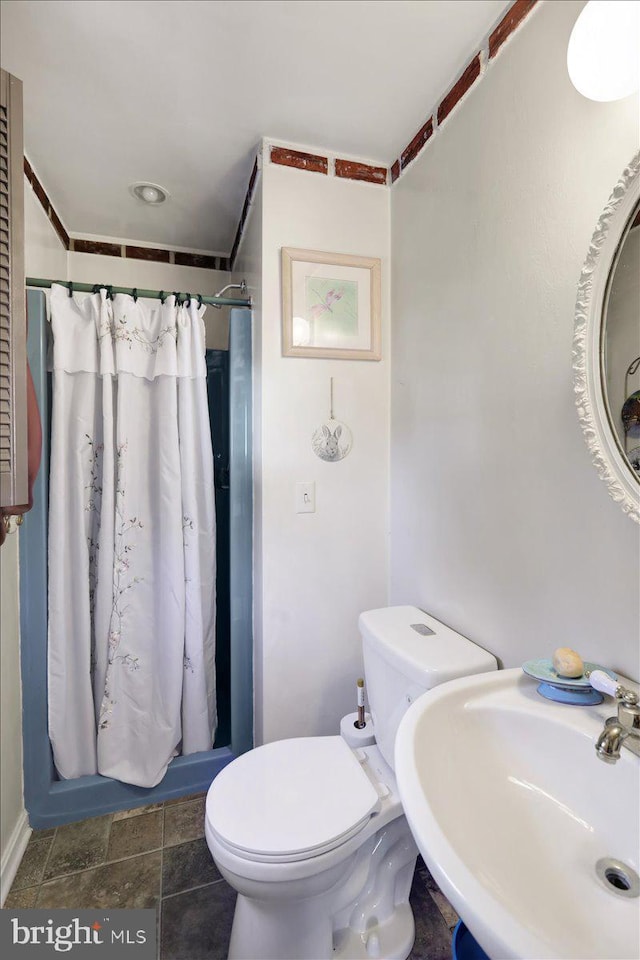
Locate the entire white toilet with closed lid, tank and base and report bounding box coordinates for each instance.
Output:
[205,606,497,960]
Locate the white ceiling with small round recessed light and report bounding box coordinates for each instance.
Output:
[0,0,510,254]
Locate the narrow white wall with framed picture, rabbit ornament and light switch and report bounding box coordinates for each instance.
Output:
[256,154,390,743]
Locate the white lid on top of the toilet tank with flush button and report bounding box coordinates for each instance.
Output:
[358,606,498,690]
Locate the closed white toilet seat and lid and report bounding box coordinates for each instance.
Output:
[206,737,381,863]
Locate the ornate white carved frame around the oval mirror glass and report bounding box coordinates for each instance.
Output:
[573,153,640,523]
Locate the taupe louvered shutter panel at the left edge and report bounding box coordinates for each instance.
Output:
[0,70,29,507]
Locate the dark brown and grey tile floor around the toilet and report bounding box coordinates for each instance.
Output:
[4,794,458,960]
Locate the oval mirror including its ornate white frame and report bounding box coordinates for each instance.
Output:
[573,153,640,523]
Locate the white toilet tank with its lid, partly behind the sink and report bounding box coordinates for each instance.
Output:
[358,607,498,769]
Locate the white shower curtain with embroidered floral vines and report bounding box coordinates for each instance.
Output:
[48,284,217,787]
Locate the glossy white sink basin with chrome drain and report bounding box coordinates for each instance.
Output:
[396,669,640,960]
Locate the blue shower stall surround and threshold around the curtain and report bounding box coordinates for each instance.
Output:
[20,290,253,829]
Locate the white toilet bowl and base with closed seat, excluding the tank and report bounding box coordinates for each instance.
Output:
[205,736,418,960]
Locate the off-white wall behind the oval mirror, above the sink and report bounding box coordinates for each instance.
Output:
[391,2,640,679]
